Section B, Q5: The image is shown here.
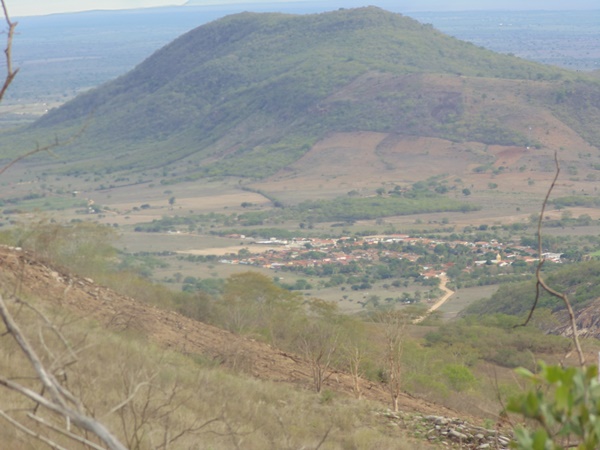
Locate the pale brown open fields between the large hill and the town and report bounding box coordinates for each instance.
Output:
[0,137,600,266]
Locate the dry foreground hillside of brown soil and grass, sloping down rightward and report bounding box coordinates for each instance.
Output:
[0,246,509,449]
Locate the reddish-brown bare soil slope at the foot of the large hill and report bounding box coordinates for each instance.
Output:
[253,125,595,203]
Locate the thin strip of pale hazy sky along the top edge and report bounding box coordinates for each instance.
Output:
[6,0,600,17]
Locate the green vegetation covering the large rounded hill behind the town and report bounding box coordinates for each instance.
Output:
[6,7,600,178]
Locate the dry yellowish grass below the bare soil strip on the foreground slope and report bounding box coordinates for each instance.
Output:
[0,288,436,450]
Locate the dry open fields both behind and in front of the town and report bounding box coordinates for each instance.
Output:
[0,114,600,330]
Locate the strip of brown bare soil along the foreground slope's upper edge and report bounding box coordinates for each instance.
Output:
[0,247,458,417]
